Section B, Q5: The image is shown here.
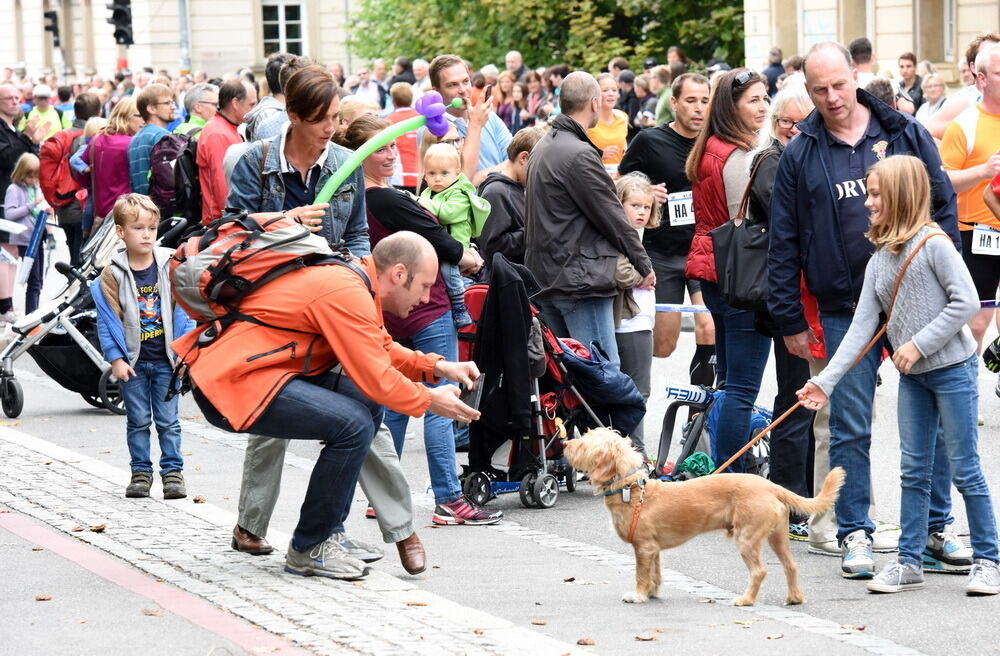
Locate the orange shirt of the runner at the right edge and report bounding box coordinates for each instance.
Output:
[939,104,1000,230]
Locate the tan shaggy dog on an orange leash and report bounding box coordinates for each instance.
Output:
[565,428,844,606]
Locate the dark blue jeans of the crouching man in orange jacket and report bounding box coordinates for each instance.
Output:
[247,371,383,551]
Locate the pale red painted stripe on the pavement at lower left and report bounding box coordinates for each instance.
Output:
[0,512,311,656]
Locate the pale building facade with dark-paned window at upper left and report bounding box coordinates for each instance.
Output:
[0,0,358,78]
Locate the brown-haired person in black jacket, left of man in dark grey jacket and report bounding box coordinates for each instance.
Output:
[477,128,542,265]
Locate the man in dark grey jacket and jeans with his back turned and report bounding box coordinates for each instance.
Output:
[525,71,656,365]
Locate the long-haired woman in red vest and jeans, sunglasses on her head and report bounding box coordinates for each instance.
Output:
[684,68,771,472]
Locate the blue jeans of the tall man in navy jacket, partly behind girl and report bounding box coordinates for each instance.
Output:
[820,315,955,551]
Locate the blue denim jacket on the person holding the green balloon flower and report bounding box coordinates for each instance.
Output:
[226,131,371,257]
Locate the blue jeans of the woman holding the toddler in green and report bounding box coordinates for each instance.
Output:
[385,312,462,503]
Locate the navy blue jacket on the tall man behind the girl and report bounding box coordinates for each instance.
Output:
[767,89,962,335]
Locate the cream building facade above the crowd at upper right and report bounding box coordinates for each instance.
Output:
[743,0,1000,82]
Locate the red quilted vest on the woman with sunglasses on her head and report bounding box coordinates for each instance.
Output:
[684,136,736,282]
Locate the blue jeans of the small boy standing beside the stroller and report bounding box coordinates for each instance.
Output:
[121,360,184,474]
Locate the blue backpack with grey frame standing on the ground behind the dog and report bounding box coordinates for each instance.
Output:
[653,387,772,478]
